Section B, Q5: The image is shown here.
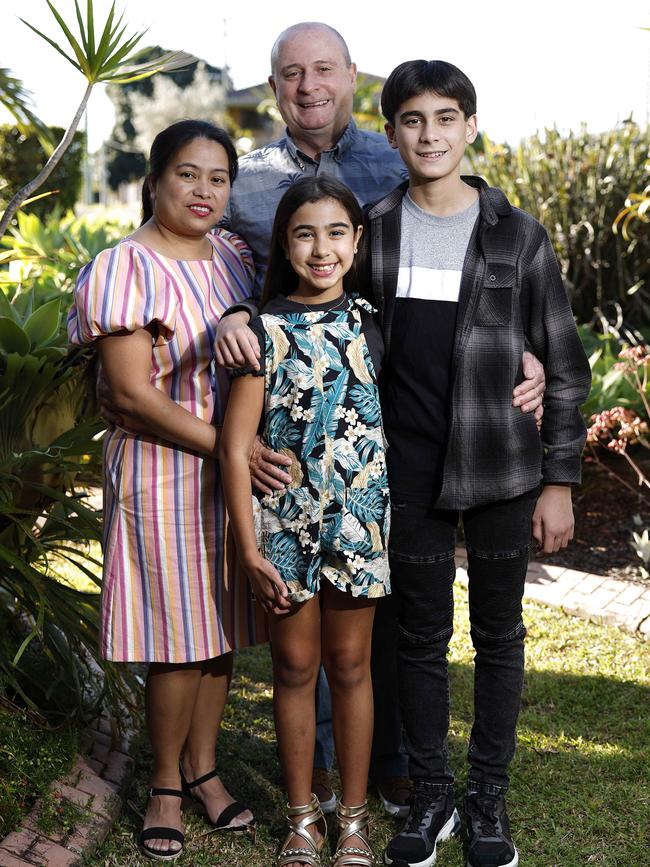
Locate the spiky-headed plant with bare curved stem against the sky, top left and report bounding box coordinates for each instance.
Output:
[0,0,195,238]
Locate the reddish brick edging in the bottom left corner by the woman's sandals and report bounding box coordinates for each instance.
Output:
[0,718,134,867]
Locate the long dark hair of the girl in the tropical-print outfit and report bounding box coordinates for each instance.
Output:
[261,175,363,306]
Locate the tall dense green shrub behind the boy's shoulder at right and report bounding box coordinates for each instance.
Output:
[469,122,650,326]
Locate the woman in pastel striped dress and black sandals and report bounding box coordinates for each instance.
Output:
[68,120,264,860]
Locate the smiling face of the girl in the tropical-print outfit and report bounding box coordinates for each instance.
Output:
[286,198,363,302]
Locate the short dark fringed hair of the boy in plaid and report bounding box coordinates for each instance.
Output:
[381,60,476,124]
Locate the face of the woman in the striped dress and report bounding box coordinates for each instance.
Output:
[152,138,230,237]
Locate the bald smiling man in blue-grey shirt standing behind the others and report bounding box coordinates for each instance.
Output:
[217,22,543,817]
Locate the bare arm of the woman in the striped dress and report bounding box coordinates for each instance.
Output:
[96,328,219,457]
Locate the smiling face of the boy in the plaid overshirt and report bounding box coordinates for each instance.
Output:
[385,92,477,183]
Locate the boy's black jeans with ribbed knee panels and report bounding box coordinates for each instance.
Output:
[390,488,539,788]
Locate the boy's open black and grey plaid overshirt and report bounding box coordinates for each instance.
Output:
[365,177,591,509]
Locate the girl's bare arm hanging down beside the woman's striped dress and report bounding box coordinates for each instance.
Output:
[219,376,291,614]
